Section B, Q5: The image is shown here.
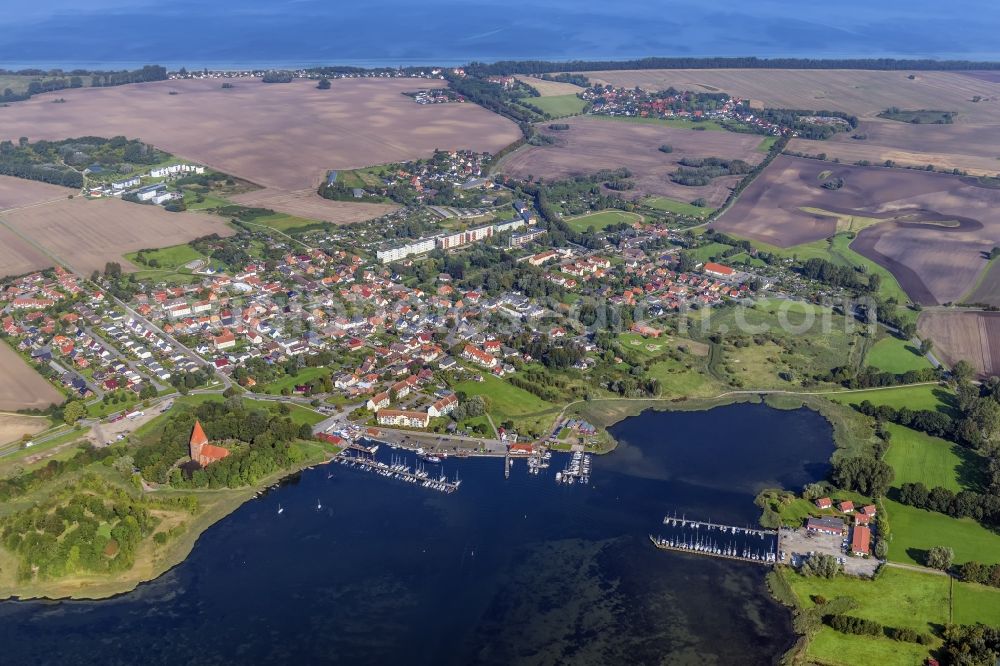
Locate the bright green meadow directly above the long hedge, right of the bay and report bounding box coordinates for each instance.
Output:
[885,423,988,493]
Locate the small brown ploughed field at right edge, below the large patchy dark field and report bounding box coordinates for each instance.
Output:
[917,311,1000,377]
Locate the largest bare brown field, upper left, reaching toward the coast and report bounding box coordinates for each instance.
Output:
[0,79,521,191]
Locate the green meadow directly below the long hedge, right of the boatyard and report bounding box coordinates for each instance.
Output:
[885,499,1000,564]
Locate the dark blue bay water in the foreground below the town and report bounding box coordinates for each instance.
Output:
[0,404,833,666]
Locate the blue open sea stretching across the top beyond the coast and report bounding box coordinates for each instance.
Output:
[0,0,1000,68]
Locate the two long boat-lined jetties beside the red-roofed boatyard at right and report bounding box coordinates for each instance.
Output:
[649,515,780,565]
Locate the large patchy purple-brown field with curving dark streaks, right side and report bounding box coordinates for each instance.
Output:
[714,155,1000,305]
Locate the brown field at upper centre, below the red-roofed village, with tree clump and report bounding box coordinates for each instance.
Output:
[500,116,764,207]
